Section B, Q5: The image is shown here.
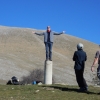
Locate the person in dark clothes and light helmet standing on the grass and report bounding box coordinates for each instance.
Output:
[73,43,88,92]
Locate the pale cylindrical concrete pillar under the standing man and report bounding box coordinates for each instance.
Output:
[44,61,52,85]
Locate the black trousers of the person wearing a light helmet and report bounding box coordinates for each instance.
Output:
[75,69,87,88]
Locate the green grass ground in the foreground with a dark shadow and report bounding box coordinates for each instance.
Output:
[0,85,100,100]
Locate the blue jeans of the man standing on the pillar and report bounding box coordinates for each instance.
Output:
[45,42,53,60]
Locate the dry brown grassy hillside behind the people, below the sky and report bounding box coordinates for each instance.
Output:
[0,26,99,84]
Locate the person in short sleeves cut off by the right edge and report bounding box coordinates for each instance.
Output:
[91,45,100,79]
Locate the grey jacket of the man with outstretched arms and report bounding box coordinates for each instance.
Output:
[35,31,63,43]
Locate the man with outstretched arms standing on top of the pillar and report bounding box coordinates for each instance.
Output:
[33,26,64,61]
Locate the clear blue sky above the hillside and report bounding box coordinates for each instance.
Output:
[0,0,100,44]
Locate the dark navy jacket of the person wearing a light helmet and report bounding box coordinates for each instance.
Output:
[73,50,87,70]
